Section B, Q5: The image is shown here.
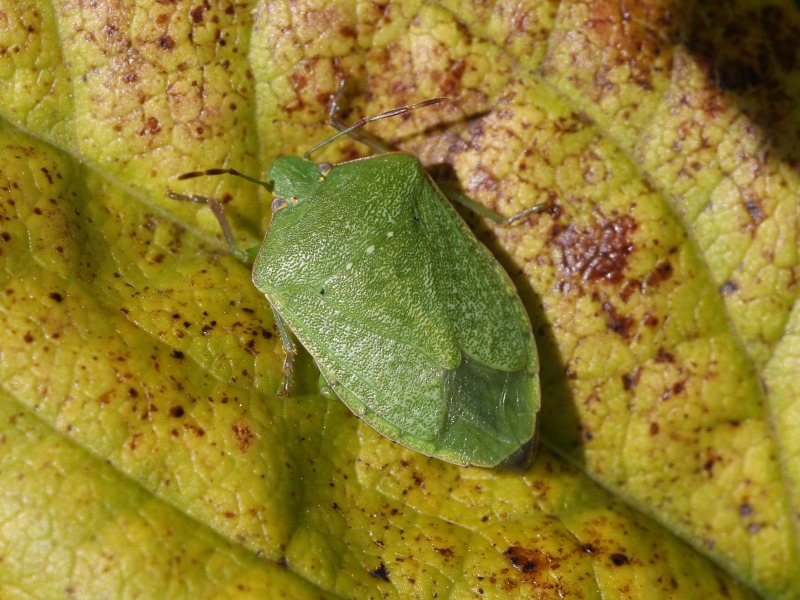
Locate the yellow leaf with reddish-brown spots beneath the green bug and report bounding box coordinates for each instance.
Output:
[0,0,800,600]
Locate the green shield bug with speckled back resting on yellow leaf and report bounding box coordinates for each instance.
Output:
[169,89,543,467]
